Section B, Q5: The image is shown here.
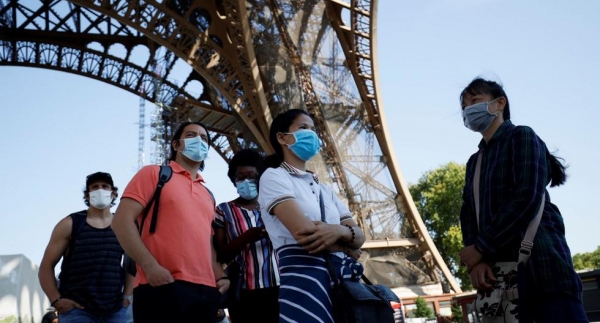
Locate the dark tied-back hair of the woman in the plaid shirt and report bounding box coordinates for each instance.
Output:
[460,77,567,187]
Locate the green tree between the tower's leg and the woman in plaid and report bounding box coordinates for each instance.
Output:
[409,162,473,290]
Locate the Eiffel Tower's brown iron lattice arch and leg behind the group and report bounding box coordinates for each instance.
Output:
[0,0,461,292]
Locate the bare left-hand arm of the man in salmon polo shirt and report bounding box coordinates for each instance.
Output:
[112,197,174,286]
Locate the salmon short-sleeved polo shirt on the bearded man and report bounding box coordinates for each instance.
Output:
[123,161,216,287]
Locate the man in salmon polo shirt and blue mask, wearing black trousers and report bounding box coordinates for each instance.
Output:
[112,122,229,323]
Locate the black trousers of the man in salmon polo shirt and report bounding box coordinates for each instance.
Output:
[133,280,221,323]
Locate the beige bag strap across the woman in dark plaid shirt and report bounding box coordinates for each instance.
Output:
[473,150,546,263]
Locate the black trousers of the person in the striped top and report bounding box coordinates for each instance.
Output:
[227,287,279,323]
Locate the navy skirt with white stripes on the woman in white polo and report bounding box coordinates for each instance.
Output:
[277,245,362,323]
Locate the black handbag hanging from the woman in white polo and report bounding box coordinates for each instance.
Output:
[319,193,400,323]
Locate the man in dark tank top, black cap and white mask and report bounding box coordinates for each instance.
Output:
[39,172,133,323]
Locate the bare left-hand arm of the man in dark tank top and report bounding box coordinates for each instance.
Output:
[38,216,83,312]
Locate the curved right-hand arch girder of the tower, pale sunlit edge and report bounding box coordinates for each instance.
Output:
[326,0,461,292]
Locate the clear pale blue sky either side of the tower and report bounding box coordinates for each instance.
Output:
[0,0,600,264]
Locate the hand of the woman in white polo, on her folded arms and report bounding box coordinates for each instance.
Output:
[297,221,344,254]
